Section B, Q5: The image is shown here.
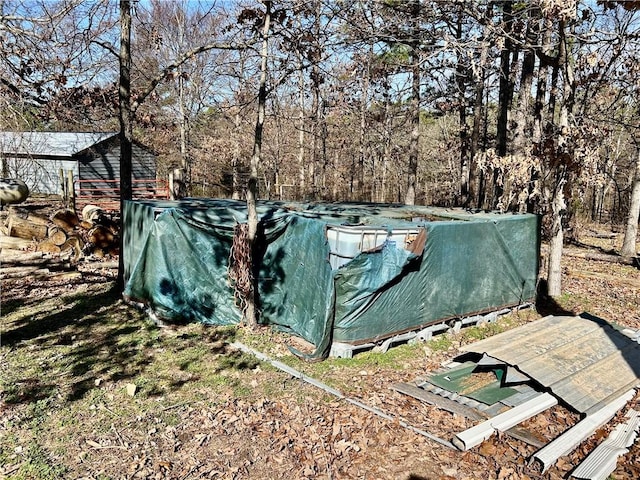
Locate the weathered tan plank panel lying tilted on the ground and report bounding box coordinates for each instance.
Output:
[461,314,640,414]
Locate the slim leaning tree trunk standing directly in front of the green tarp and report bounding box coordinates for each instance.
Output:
[244,0,271,328]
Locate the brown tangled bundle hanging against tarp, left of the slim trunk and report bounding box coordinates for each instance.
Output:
[227,223,253,317]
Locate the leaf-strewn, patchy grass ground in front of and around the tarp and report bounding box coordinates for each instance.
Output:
[0,224,640,480]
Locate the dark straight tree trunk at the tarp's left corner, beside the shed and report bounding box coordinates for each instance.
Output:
[116,0,133,290]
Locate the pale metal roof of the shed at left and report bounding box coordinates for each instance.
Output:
[0,132,117,158]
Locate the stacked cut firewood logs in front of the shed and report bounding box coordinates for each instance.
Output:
[3,205,119,261]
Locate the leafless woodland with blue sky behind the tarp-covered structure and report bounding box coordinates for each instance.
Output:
[0,0,640,294]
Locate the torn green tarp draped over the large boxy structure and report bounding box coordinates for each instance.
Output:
[123,200,538,358]
